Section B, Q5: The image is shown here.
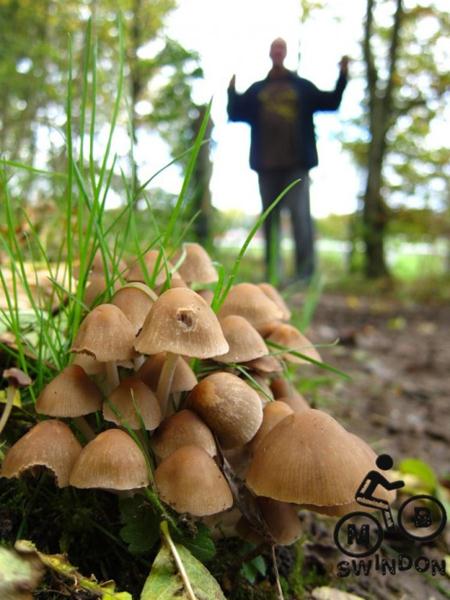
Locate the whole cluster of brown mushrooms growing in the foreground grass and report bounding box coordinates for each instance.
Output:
[0,244,390,544]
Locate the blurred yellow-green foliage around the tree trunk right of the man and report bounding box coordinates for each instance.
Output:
[344,0,450,208]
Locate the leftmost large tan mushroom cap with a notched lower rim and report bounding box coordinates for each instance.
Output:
[0,419,82,488]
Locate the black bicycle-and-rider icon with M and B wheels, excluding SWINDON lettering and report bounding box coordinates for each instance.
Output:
[334,454,447,558]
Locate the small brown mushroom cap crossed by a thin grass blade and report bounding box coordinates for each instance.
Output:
[103,376,162,431]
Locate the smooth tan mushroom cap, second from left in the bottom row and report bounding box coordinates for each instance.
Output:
[70,429,149,490]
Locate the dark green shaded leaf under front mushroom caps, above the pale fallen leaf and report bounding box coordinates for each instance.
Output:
[119,496,159,554]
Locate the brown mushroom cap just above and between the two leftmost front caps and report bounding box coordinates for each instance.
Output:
[36,365,102,417]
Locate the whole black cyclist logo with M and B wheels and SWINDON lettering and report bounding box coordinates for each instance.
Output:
[334,454,447,577]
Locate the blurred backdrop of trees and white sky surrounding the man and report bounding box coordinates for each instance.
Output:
[0,0,450,297]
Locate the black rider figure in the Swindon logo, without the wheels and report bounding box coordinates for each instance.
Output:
[355,454,405,529]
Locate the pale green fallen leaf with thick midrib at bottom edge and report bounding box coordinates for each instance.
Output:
[140,544,226,600]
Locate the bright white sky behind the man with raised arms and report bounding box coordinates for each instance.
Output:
[142,0,365,217]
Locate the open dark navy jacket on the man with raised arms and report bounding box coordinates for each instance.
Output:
[227,70,347,171]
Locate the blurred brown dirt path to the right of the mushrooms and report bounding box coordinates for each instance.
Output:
[311,296,450,476]
